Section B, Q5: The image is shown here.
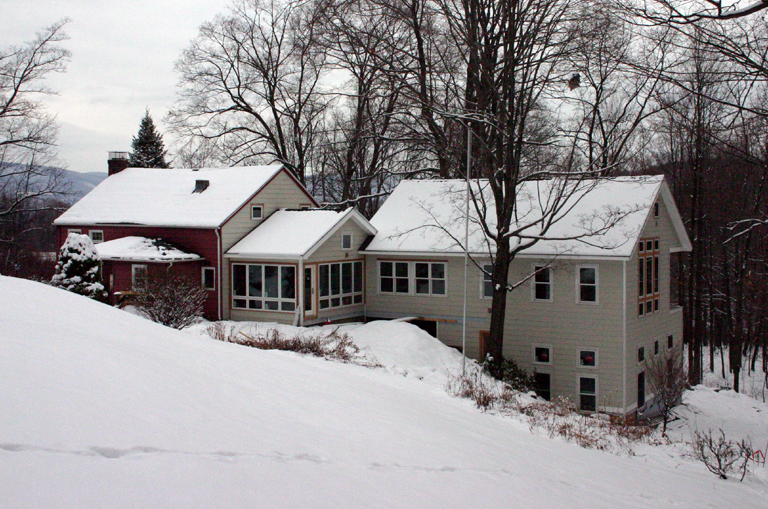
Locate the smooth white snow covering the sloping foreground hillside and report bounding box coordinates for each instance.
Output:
[0,277,768,509]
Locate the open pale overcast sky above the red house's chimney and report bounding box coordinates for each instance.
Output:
[0,0,234,172]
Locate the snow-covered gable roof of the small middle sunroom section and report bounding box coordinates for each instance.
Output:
[227,208,376,258]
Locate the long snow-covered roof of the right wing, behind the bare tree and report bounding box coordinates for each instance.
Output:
[366,176,690,258]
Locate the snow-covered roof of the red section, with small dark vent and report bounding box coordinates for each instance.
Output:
[54,164,296,228]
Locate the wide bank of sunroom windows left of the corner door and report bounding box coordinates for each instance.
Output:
[232,264,296,311]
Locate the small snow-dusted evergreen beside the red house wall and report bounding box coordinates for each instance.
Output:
[51,233,106,300]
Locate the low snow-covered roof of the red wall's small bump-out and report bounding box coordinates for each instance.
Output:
[96,237,202,262]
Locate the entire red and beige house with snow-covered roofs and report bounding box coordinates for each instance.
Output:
[55,161,691,414]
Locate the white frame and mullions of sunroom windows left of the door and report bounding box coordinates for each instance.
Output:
[230,262,299,313]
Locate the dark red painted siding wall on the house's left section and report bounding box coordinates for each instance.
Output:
[56,225,221,320]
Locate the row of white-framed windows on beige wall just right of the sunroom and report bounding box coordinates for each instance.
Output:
[379,261,447,295]
